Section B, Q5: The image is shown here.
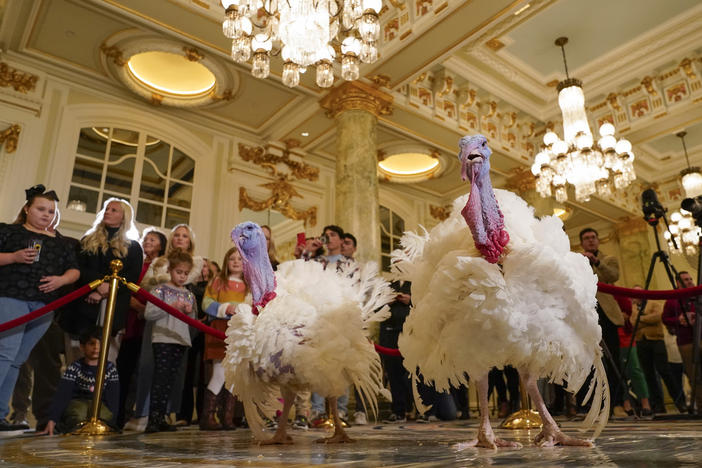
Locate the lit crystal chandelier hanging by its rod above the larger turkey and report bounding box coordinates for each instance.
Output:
[531,37,636,203]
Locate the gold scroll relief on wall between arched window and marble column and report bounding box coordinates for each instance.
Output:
[239,143,319,226]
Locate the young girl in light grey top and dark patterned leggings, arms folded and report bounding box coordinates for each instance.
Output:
[144,250,196,433]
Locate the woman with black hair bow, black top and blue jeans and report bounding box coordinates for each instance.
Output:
[0,185,80,431]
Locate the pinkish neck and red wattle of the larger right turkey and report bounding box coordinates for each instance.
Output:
[461,164,509,263]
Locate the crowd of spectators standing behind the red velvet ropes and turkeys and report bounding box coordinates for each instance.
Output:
[0,185,702,434]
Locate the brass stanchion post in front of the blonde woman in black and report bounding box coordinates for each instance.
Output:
[72,260,124,435]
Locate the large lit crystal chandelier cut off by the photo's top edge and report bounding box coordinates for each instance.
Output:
[222,0,382,88]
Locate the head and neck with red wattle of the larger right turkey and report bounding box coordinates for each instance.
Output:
[458,135,509,263]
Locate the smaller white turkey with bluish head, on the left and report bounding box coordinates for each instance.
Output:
[222,222,394,444]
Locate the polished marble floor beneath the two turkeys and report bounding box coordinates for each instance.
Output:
[0,419,702,468]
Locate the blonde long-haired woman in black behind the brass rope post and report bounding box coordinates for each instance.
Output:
[62,198,143,336]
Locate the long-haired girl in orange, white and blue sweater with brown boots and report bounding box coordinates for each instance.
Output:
[200,247,248,430]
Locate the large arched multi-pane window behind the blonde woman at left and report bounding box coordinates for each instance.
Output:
[68,127,195,228]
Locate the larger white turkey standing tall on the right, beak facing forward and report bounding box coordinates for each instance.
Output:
[394,135,609,448]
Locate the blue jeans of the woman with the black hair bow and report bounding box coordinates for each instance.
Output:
[0,297,54,419]
